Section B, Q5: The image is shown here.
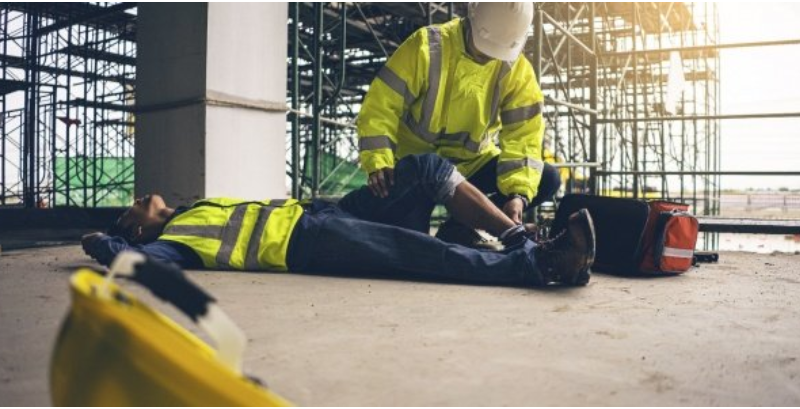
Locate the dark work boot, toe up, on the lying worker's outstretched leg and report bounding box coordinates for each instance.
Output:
[534,209,595,285]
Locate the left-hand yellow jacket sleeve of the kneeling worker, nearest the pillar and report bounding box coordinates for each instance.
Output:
[357,29,428,173]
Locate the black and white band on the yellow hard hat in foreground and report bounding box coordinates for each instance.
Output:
[101,251,247,374]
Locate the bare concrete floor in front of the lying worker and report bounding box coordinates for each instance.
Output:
[0,246,800,406]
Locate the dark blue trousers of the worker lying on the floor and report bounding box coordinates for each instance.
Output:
[287,154,546,285]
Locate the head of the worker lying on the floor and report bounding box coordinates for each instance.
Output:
[108,194,172,244]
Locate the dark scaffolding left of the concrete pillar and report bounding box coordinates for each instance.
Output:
[0,3,136,208]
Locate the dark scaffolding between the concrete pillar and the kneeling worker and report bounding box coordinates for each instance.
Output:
[287,3,466,197]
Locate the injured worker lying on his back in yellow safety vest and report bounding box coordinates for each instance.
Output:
[83,155,594,285]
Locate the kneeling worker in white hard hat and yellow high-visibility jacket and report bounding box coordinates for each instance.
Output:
[358,3,561,248]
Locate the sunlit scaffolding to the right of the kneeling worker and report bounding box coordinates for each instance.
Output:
[528,3,719,207]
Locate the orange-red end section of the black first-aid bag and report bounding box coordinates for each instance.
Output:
[639,201,700,274]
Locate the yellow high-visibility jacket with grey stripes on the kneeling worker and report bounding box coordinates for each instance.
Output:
[358,19,544,200]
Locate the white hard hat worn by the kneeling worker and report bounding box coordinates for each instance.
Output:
[469,2,533,61]
